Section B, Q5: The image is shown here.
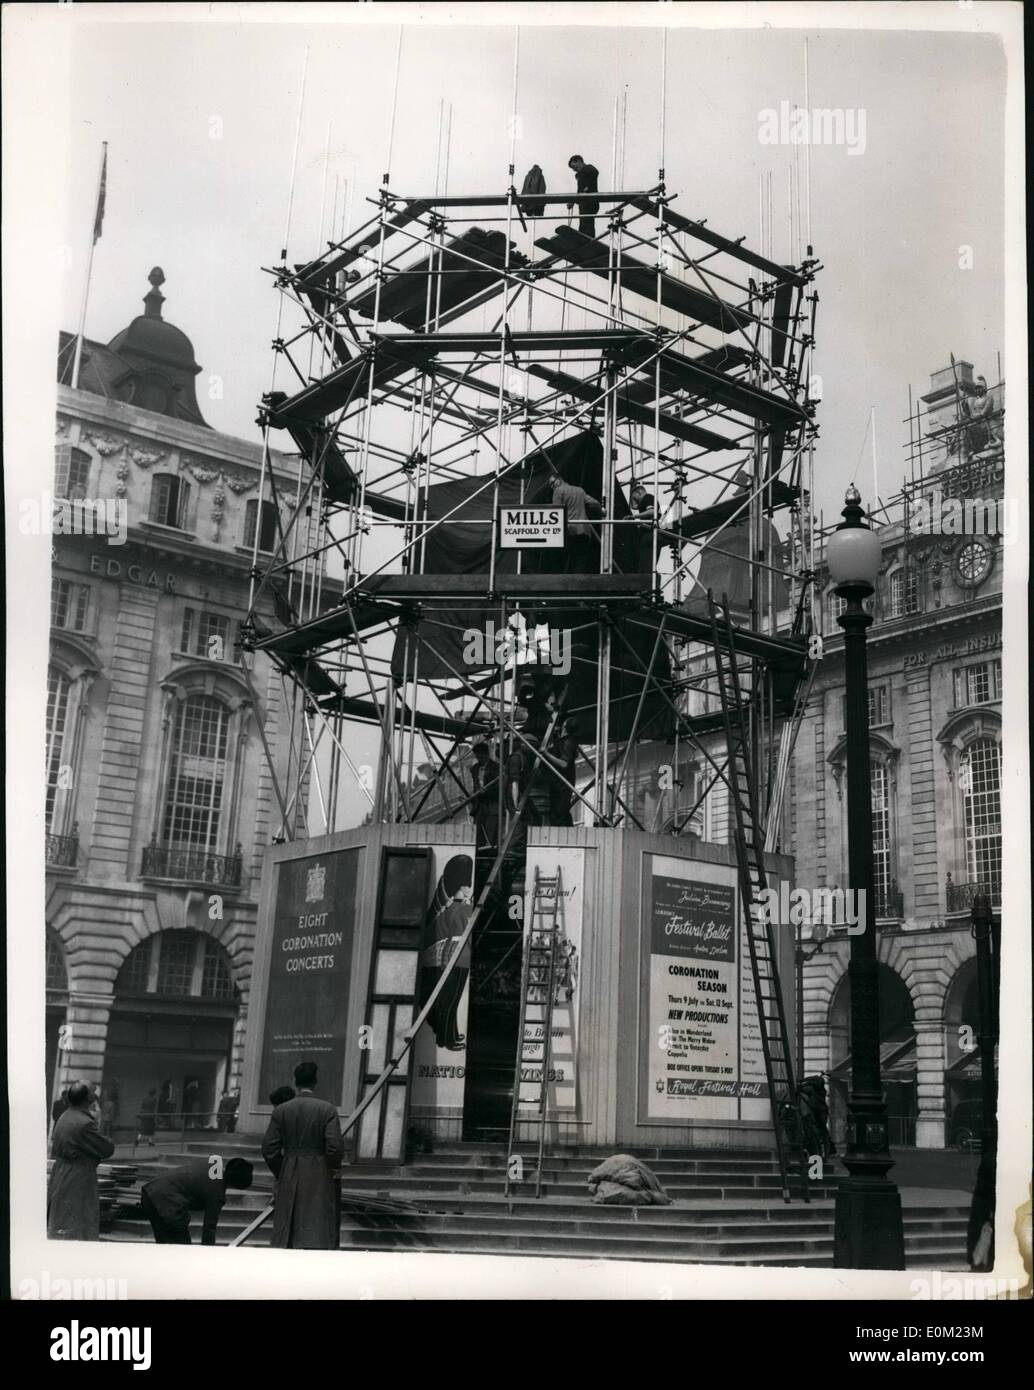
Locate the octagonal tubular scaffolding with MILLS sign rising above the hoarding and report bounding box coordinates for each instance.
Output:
[230,40,820,1217]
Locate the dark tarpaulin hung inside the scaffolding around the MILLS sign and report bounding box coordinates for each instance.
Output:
[392,431,671,742]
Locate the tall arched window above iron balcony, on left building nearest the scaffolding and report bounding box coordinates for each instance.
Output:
[163,695,229,852]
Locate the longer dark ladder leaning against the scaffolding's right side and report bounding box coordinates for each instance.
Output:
[707,589,810,1202]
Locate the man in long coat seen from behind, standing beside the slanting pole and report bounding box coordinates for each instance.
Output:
[263,1062,345,1250]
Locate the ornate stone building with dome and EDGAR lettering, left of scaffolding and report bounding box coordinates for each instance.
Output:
[46,268,326,1129]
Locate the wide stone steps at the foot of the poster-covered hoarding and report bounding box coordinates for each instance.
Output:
[104,1136,969,1269]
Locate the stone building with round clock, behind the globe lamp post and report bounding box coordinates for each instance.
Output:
[784,361,1008,1148]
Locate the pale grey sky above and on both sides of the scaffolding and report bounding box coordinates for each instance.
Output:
[44,6,1008,518]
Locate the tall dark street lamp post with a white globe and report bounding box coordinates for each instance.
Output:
[826,485,905,1269]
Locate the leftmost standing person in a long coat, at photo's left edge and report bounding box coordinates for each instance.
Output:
[47,1081,115,1240]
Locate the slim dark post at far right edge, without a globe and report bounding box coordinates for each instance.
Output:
[966,892,999,1269]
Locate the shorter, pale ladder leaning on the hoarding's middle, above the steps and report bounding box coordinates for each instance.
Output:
[504,866,560,1197]
